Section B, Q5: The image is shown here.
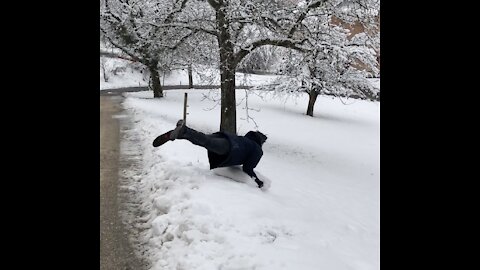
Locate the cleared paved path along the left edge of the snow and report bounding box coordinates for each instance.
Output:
[100,95,146,270]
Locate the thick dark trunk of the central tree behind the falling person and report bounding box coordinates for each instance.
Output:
[216,3,237,134]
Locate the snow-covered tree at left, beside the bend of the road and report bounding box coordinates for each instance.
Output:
[100,0,200,97]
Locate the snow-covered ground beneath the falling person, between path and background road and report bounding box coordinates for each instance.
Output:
[122,87,380,270]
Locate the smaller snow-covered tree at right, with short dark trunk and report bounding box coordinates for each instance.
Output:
[268,1,379,116]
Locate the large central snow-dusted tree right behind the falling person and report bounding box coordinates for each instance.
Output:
[148,0,344,133]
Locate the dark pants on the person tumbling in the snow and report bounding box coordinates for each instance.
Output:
[178,126,230,155]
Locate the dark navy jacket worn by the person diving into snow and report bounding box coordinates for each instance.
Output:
[208,131,263,178]
